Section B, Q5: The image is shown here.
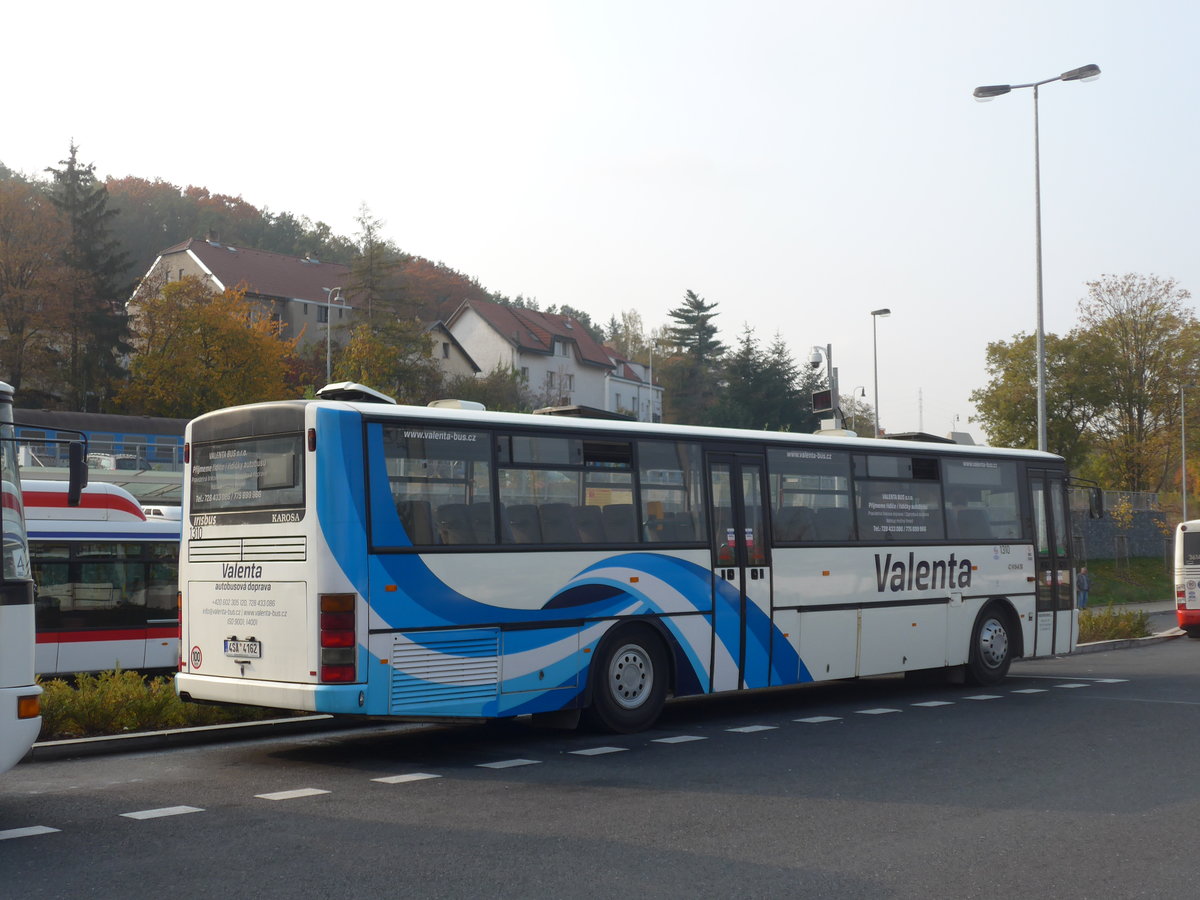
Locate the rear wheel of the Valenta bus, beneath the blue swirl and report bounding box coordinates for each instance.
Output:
[584,625,667,734]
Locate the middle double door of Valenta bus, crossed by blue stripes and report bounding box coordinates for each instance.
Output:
[708,454,772,691]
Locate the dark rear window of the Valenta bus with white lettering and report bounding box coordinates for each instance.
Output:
[188,434,304,514]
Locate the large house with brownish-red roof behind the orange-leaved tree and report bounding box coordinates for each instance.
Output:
[131,234,355,346]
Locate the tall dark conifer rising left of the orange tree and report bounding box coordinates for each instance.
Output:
[47,142,132,410]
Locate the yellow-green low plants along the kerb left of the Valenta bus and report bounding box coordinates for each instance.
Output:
[38,670,290,740]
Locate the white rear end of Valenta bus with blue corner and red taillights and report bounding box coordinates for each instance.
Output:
[176,401,366,713]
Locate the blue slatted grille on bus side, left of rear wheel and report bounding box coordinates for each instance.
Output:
[391,629,500,715]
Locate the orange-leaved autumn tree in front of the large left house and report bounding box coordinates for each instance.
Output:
[116,277,295,419]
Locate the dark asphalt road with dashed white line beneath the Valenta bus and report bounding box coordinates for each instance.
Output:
[0,638,1200,899]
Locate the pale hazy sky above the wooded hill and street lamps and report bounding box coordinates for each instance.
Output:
[0,0,1200,437]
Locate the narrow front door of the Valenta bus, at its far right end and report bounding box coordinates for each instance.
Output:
[1030,469,1078,656]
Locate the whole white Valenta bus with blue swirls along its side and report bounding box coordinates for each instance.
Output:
[176,384,1078,731]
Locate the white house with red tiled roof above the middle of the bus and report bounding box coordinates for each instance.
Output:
[446,300,662,421]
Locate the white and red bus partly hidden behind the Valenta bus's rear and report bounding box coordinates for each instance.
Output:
[23,481,180,674]
